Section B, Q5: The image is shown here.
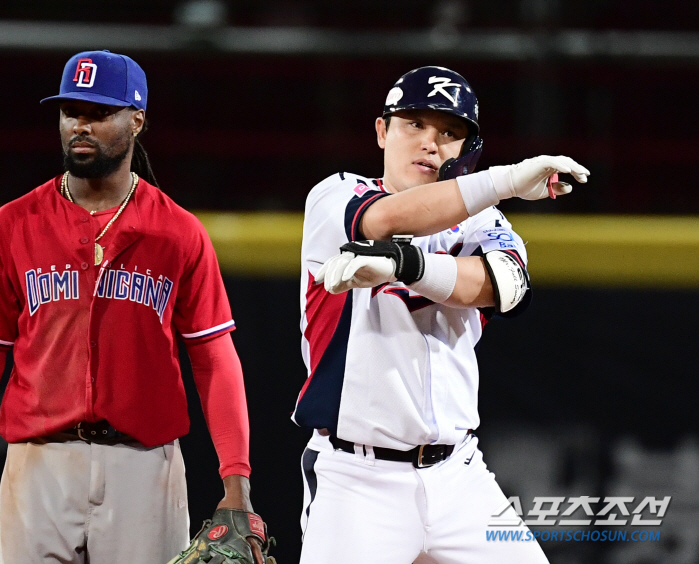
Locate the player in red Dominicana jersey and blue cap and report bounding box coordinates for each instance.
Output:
[0,51,265,564]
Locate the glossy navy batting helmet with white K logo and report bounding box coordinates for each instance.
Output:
[383,67,483,172]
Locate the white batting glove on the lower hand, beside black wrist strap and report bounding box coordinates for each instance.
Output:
[315,251,396,294]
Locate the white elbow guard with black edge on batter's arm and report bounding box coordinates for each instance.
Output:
[483,251,532,317]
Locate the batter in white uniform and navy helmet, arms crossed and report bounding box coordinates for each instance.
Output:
[293,67,589,564]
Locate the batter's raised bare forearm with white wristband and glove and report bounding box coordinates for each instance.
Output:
[360,155,590,240]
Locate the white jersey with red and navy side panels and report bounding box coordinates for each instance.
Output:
[293,172,526,450]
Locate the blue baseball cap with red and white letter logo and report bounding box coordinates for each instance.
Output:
[41,51,148,110]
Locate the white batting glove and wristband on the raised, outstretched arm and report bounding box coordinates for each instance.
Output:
[456,155,590,216]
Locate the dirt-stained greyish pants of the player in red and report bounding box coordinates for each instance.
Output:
[0,441,189,564]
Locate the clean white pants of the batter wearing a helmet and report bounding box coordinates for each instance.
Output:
[301,434,548,564]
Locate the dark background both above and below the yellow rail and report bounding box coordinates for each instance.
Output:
[0,0,699,564]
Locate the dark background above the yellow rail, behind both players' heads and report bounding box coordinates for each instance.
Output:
[0,0,699,214]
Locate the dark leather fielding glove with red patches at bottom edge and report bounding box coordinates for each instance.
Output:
[168,509,276,564]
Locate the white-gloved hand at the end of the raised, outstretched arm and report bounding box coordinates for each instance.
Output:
[488,155,590,200]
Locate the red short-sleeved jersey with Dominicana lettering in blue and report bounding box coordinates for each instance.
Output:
[0,176,235,446]
